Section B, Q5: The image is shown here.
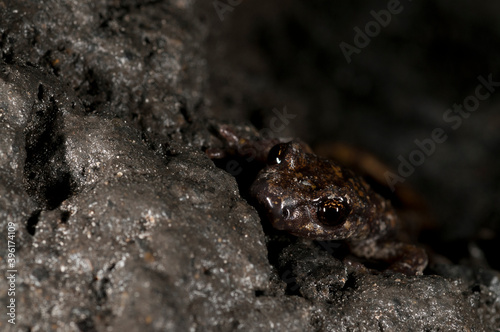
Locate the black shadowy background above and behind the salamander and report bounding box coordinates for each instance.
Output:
[208,0,500,268]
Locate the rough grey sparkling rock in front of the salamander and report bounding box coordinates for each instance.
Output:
[0,0,500,332]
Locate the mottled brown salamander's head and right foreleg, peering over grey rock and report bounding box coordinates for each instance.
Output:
[250,142,427,275]
